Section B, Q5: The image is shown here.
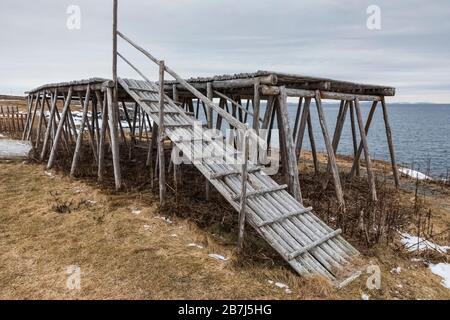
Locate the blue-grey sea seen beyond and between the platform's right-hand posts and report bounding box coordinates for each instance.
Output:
[282,102,450,177]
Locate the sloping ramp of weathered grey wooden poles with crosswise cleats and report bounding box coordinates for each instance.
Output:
[118,79,358,284]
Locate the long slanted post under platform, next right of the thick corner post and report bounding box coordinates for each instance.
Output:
[315,90,345,208]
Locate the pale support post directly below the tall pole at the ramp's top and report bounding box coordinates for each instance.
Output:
[106,88,122,190]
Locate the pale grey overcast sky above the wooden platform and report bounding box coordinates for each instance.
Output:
[0,0,450,103]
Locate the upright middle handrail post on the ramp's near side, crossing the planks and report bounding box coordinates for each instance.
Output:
[158,61,166,207]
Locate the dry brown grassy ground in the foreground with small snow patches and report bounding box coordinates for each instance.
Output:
[0,151,450,299]
